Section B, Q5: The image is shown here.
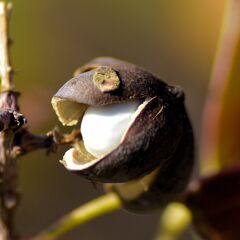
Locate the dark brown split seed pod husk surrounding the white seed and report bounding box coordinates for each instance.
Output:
[52,58,193,210]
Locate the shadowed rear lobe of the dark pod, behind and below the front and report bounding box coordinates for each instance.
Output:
[106,97,194,213]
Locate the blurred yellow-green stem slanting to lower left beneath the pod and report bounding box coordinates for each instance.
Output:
[31,192,121,240]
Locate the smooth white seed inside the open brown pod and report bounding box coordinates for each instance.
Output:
[81,100,141,157]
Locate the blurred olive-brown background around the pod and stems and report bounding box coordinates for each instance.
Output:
[7,0,224,240]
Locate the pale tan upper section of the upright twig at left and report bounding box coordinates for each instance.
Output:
[0,2,14,92]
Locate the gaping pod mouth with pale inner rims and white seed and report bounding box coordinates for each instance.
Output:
[52,98,150,171]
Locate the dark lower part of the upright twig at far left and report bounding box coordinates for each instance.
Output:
[0,95,21,240]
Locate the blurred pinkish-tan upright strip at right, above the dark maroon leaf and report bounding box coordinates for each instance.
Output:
[200,0,240,174]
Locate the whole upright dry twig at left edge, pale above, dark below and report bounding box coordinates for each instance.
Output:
[0,2,21,240]
